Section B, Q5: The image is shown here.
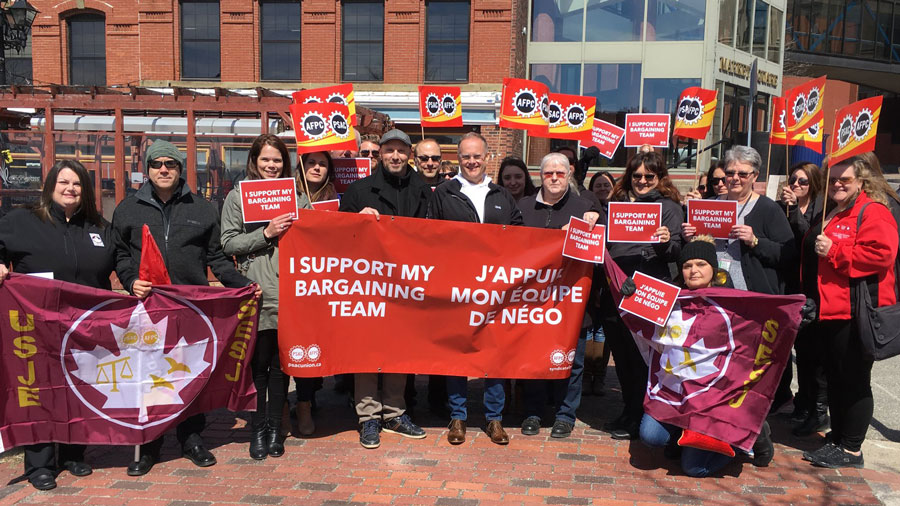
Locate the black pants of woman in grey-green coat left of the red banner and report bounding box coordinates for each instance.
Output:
[250,329,289,428]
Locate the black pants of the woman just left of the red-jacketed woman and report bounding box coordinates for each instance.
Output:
[794,322,828,415]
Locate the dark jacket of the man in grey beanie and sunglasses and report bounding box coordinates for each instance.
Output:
[112,181,250,291]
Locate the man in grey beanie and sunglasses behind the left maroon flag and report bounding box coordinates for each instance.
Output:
[112,140,250,476]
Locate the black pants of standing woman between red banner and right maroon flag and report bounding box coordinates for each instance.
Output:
[603,315,649,424]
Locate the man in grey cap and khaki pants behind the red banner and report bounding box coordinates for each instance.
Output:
[340,129,431,448]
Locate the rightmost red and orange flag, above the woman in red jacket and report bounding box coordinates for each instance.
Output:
[828,95,884,165]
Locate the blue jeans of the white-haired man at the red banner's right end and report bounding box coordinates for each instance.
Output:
[523,328,588,425]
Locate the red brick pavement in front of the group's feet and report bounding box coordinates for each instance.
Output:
[0,375,900,506]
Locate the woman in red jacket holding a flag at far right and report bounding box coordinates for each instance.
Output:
[802,152,898,468]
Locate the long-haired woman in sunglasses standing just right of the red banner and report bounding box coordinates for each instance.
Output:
[600,151,684,439]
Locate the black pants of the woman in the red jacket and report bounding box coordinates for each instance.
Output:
[819,320,875,452]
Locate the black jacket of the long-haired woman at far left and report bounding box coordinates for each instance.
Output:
[0,204,115,290]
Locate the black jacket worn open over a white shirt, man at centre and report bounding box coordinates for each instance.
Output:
[428,179,524,225]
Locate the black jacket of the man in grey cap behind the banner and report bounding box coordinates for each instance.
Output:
[340,162,432,218]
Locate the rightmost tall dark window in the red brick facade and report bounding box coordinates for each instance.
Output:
[425,0,469,82]
